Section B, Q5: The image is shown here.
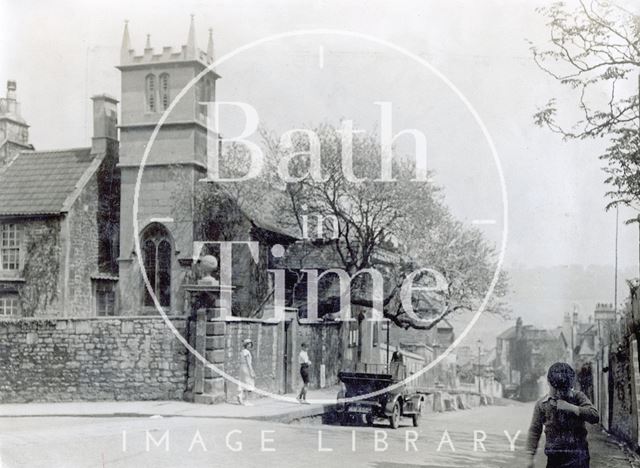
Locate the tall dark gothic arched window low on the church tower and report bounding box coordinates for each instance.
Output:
[142,224,173,307]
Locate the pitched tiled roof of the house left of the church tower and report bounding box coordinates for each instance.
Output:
[0,148,100,216]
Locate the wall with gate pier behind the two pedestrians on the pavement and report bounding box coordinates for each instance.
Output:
[185,312,343,403]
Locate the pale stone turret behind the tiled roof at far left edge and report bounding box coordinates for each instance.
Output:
[0,80,33,171]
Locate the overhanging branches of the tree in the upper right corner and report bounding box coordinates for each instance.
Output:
[531,0,640,209]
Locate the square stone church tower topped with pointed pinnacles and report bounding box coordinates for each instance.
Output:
[117,16,219,314]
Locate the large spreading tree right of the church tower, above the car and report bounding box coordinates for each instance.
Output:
[196,125,507,329]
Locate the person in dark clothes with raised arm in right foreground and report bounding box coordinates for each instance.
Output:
[527,362,600,468]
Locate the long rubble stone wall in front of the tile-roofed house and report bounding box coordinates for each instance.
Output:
[0,317,187,403]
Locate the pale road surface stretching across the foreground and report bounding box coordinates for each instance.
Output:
[0,405,632,468]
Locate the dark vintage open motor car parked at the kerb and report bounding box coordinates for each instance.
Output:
[336,363,426,429]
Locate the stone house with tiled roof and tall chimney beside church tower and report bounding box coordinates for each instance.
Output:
[0,95,120,317]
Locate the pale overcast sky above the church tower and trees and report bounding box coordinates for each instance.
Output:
[0,0,638,330]
